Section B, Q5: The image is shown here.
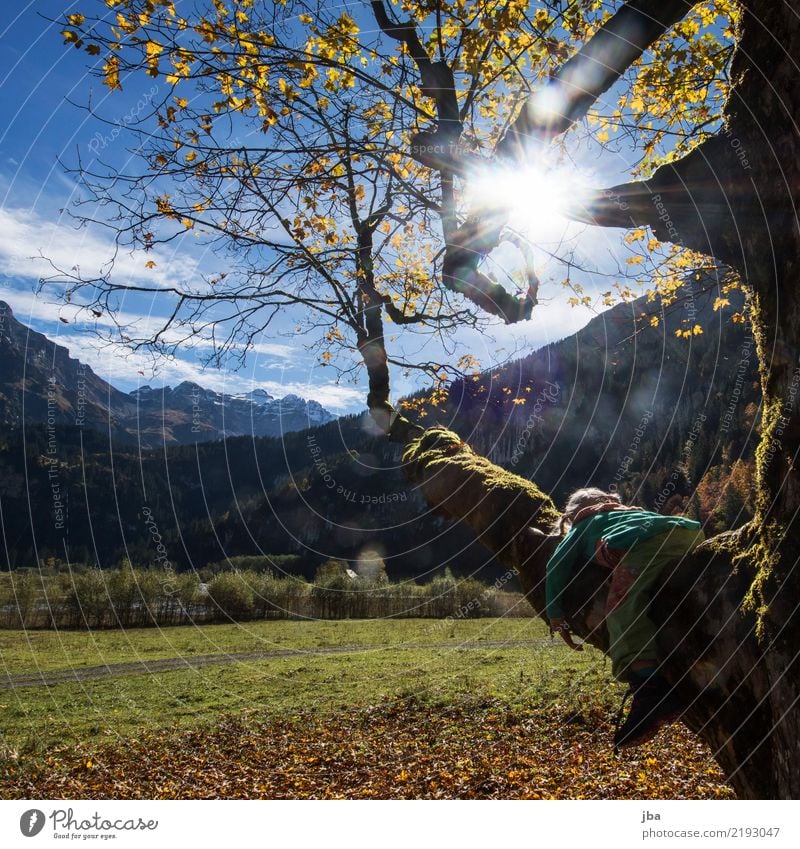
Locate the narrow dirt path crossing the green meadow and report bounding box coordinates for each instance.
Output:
[0,640,548,690]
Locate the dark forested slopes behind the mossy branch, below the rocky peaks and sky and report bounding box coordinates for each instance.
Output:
[0,284,760,580]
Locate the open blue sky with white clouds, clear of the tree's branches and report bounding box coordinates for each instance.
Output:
[0,0,640,413]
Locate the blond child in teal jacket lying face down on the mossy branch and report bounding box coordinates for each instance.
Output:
[546,488,704,748]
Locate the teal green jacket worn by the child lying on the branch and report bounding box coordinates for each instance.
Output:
[545,510,700,619]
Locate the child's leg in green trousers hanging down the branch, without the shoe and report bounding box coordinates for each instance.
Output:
[606,527,704,681]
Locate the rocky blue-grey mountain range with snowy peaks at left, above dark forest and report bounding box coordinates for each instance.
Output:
[0,301,336,448]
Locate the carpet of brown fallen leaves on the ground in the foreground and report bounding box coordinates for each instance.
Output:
[0,699,733,799]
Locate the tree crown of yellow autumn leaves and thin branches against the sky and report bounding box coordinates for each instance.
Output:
[57,0,736,422]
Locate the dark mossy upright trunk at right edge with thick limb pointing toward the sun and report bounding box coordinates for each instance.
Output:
[588,0,800,798]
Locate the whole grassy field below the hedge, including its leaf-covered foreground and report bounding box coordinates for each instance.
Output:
[0,619,728,798]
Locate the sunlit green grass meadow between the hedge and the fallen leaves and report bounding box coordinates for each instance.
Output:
[0,619,620,753]
